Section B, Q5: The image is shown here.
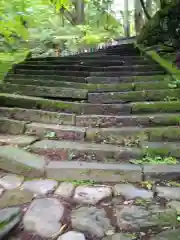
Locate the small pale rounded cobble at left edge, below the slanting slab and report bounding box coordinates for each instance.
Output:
[0,174,24,190]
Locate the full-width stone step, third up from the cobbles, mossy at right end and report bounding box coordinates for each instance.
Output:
[0,117,180,144]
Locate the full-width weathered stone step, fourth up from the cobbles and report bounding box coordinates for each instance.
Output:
[0,107,180,128]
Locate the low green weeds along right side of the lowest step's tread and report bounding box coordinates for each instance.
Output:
[131,154,177,164]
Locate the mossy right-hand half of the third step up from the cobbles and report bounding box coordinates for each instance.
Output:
[85,126,180,144]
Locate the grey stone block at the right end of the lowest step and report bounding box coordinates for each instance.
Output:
[143,164,180,180]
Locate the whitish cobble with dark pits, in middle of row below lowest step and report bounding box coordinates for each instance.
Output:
[74,186,112,205]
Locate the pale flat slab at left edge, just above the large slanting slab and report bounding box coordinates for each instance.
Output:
[0,134,38,147]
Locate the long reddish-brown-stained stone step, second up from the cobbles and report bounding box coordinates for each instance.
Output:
[30,140,142,162]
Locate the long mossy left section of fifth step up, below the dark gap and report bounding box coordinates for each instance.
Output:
[0,93,131,115]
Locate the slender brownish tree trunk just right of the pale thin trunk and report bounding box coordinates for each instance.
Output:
[134,0,144,35]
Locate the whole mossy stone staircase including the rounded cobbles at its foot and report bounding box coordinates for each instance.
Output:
[0,44,180,240]
